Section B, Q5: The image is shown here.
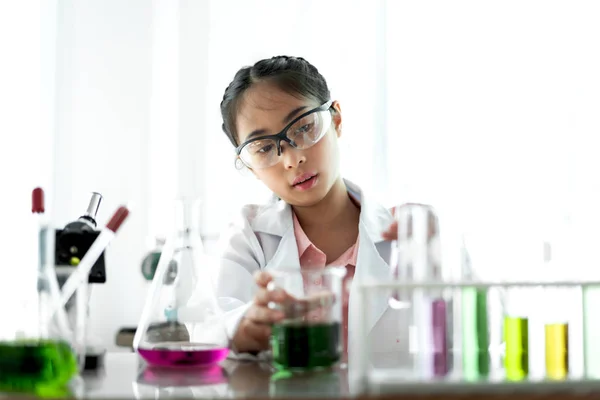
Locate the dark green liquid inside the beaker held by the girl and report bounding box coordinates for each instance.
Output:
[271,322,340,370]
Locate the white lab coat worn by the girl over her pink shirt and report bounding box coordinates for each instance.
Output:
[217,180,408,366]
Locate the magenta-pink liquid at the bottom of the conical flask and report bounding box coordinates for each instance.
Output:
[138,342,229,368]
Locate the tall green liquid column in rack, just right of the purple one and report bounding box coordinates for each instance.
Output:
[462,288,490,380]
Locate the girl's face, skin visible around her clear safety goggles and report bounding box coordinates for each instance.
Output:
[236,82,342,207]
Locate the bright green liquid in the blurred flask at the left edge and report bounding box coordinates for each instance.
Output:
[0,339,77,397]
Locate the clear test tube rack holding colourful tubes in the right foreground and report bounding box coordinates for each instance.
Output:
[353,281,600,395]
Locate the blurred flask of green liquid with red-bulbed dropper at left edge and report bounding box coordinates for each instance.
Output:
[0,188,78,397]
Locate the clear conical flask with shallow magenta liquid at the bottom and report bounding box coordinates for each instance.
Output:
[133,198,229,367]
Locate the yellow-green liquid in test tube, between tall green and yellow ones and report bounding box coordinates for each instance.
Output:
[504,317,529,381]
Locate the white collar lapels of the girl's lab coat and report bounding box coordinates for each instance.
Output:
[252,179,392,243]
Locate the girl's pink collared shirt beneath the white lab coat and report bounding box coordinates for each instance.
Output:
[292,213,358,354]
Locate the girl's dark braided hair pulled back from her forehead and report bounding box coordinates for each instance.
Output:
[221,56,330,147]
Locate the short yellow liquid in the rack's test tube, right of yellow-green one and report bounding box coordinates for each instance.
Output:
[545,324,569,380]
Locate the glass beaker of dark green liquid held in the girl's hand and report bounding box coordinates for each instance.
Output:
[267,266,346,371]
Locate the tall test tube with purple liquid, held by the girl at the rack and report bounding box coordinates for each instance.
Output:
[396,204,451,379]
